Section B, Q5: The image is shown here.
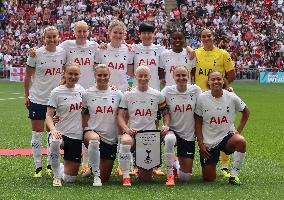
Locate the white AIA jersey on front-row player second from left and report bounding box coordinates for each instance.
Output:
[83,86,122,144]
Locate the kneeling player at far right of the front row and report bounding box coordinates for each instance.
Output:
[195,71,249,185]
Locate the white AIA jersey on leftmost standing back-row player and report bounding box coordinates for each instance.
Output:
[27,46,66,105]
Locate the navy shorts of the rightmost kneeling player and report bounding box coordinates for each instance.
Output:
[200,133,234,167]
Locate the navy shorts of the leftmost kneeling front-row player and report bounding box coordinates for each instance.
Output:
[62,135,82,163]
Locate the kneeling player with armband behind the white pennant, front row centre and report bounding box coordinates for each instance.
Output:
[118,66,176,186]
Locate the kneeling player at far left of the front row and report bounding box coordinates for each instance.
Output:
[46,63,84,187]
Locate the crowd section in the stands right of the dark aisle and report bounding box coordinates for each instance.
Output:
[178,0,284,76]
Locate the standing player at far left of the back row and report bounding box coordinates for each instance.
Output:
[24,26,66,177]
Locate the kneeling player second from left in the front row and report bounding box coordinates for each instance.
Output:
[83,64,122,186]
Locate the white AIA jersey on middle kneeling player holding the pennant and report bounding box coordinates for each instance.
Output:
[119,87,166,130]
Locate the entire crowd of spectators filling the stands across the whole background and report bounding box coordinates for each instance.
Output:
[0,0,284,79]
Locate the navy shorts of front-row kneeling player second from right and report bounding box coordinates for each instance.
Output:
[175,134,195,159]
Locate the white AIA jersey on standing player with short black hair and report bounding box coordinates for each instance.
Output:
[133,43,166,91]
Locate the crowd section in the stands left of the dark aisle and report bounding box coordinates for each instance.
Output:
[0,0,169,76]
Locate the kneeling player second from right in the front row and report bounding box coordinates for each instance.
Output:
[162,66,202,182]
